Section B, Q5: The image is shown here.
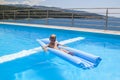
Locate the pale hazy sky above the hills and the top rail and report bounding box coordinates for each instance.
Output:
[0,0,120,8]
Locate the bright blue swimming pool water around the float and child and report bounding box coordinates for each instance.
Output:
[0,24,120,80]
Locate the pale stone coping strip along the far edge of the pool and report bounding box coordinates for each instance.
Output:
[0,22,120,35]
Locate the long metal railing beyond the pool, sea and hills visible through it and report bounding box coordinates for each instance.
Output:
[0,8,120,31]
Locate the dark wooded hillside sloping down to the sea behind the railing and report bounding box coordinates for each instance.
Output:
[0,5,103,19]
